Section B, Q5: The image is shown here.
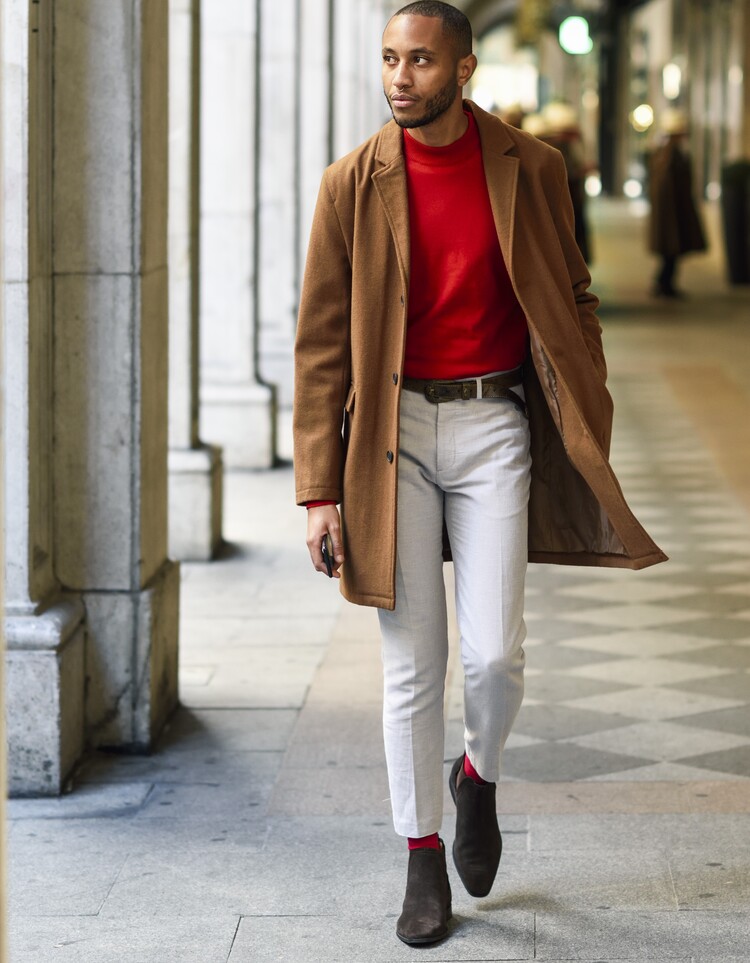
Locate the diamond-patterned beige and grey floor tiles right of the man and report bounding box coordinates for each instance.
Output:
[453,374,750,782]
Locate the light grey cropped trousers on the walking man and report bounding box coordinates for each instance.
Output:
[378,386,531,837]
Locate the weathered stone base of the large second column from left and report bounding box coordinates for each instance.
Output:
[84,560,180,752]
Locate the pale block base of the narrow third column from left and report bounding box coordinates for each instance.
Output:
[169,445,224,562]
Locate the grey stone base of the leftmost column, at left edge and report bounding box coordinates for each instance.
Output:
[5,598,86,796]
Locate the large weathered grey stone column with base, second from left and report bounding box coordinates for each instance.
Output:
[52,0,179,749]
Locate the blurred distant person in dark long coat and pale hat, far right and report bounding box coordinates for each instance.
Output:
[649,108,706,298]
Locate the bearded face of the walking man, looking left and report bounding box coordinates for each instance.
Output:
[383,15,473,127]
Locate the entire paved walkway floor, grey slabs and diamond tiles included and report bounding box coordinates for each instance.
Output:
[9,205,750,963]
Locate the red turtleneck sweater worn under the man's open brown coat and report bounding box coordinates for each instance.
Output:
[404,111,527,378]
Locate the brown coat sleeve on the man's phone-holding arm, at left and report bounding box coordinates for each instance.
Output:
[293,172,351,504]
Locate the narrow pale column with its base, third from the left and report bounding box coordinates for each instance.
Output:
[168,0,222,561]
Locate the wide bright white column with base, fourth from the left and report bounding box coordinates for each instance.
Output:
[200,0,276,468]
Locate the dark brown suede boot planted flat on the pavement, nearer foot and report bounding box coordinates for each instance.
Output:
[396,839,453,946]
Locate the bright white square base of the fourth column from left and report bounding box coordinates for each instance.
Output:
[200,383,276,469]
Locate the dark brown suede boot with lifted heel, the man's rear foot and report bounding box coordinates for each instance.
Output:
[448,755,503,896]
